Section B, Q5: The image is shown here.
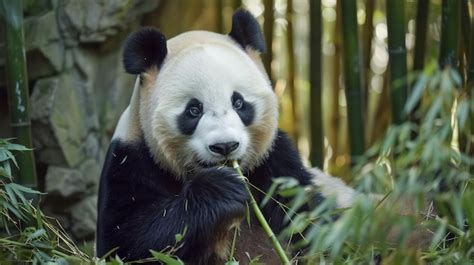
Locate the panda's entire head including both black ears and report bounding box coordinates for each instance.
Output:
[124,10,278,177]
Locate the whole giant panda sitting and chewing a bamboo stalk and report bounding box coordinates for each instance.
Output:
[96,10,362,264]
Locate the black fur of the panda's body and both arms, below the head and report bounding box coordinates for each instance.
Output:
[97,132,322,264]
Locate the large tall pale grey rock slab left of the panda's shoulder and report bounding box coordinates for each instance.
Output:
[31,74,89,167]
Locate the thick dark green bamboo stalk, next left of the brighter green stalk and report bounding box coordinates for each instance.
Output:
[341,1,365,164]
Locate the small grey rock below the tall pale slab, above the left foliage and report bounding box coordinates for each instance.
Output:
[45,166,86,200]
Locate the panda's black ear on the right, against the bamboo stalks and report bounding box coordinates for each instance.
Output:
[229,9,265,53]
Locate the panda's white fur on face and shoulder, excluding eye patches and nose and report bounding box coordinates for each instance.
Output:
[114,31,278,177]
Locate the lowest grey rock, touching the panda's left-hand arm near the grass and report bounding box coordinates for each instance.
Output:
[71,195,97,239]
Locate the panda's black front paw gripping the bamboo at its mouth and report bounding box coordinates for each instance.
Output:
[186,167,249,219]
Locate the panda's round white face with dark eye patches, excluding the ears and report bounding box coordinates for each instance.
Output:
[140,35,278,177]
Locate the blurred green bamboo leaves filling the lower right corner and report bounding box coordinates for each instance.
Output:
[267,64,474,264]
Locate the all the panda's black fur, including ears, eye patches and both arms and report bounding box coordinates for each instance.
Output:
[96,10,323,264]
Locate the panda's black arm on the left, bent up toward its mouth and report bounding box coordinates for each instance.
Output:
[97,139,247,261]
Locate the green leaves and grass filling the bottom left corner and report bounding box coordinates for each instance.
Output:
[0,139,90,264]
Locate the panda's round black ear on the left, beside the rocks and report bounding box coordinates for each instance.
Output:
[123,27,168,75]
